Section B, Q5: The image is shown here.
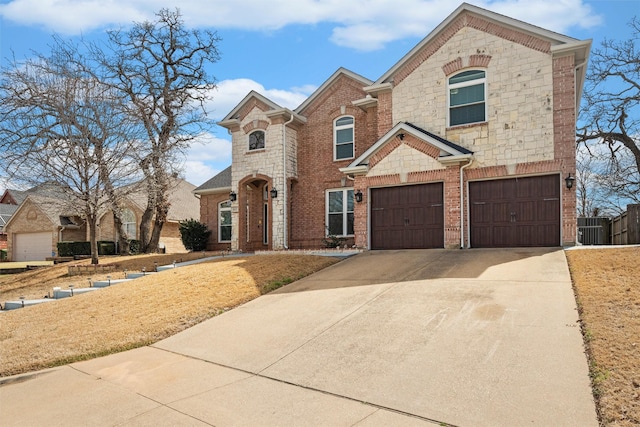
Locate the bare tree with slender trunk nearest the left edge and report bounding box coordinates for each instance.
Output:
[0,42,141,264]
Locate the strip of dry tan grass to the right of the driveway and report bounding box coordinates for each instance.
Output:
[567,247,640,426]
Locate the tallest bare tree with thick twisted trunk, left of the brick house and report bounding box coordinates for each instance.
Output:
[92,9,220,252]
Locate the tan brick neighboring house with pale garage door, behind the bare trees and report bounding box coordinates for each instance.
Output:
[5,179,199,261]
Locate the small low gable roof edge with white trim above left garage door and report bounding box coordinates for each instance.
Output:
[340,122,473,174]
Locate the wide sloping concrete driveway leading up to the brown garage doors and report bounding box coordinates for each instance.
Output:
[0,249,598,426]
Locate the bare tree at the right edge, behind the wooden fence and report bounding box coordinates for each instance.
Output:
[577,18,640,211]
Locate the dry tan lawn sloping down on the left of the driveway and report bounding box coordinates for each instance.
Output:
[0,255,337,376]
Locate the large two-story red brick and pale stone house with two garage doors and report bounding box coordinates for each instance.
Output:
[194,4,591,251]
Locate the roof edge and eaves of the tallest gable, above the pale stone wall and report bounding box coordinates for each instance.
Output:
[376,3,591,105]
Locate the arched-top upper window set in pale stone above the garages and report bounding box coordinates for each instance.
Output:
[449,70,487,126]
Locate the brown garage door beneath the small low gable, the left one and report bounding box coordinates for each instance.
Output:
[371,183,444,249]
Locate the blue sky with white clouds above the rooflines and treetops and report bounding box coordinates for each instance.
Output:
[0,0,640,192]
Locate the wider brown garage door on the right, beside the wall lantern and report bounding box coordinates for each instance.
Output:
[469,175,560,248]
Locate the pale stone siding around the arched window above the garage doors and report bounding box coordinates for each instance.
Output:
[393,27,554,167]
